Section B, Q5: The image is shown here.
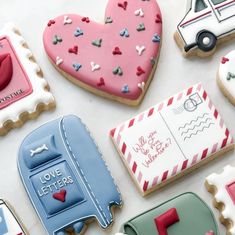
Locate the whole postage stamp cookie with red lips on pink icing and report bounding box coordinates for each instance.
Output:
[0,23,55,135]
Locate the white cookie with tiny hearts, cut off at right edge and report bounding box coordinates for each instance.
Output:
[217,51,235,105]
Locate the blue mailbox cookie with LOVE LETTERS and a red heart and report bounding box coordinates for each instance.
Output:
[18,115,122,235]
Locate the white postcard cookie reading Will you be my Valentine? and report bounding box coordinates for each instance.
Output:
[111,84,234,195]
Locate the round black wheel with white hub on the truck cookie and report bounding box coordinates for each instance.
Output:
[197,32,217,52]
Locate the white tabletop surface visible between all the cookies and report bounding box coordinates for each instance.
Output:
[0,0,235,235]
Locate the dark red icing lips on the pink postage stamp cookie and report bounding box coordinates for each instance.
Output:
[0,54,13,91]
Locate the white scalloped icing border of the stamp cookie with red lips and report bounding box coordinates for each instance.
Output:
[0,23,55,128]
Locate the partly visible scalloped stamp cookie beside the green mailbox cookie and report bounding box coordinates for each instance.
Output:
[206,166,235,235]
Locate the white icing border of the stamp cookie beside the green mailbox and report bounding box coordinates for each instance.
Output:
[206,165,235,235]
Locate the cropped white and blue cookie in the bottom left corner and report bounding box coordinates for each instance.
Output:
[0,199,26,235]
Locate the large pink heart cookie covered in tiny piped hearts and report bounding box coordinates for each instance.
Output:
[44,0,162,105]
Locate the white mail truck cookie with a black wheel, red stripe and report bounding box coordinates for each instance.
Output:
[175,0,235,57]
